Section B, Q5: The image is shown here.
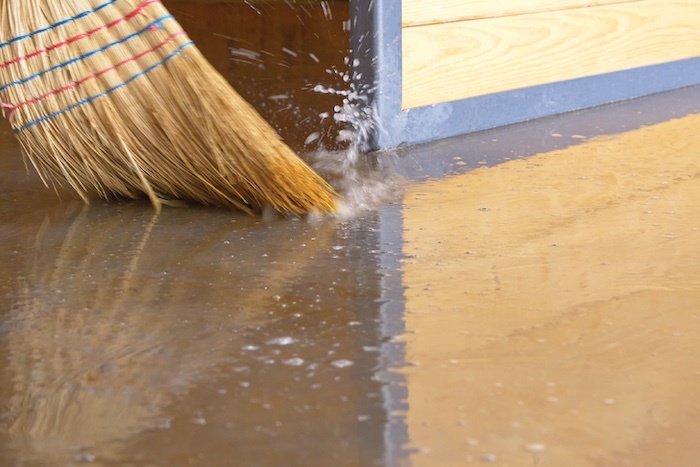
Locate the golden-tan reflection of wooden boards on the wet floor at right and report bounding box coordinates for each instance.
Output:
[401,110,700,467]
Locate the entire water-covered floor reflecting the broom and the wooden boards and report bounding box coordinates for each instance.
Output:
[0,2,700,467]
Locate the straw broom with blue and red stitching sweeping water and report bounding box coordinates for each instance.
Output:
[0,0,336,215]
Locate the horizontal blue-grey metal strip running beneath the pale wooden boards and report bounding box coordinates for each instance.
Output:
[394,58,700,149]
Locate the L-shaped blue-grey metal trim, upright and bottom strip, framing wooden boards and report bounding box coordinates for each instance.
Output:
[350,0,700,149]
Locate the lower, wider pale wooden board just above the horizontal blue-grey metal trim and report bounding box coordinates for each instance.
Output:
[402,0,700,109]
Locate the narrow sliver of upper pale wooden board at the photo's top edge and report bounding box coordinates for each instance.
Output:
[401,0,647,27]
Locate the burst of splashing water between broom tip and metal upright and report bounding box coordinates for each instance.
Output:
[224,0,403,219]
